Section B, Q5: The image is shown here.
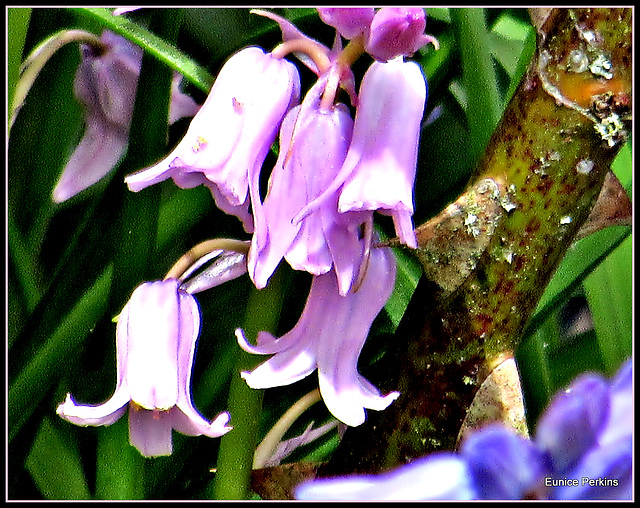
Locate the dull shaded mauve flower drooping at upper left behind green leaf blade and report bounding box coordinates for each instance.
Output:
[52,31,199,203]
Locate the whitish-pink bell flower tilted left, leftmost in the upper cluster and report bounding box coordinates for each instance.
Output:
[125,46,300,231]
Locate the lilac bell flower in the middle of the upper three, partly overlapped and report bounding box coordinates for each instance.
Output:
[248,80,366,294]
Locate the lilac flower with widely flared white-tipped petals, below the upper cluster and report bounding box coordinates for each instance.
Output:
[236,244,399,426]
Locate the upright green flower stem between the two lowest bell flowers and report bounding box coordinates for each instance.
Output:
[209,272,282,500]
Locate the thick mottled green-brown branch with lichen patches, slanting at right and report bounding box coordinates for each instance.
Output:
[319,9,632,476]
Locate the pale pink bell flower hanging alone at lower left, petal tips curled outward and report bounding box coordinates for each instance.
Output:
[57,279,231,457]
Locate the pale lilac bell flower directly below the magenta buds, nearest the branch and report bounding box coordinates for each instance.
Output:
[296,59,427,248]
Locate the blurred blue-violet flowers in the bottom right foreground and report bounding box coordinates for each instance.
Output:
[296,360,633,500]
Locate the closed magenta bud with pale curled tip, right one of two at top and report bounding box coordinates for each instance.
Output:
[364,7,437,62]
